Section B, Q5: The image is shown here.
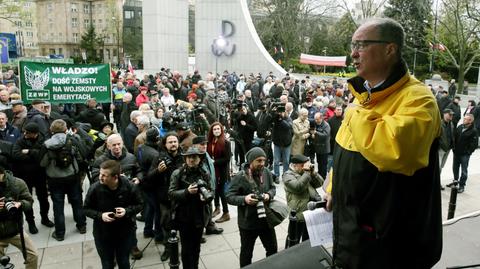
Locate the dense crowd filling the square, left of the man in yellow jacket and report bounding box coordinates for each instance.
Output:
[0,56,349,268]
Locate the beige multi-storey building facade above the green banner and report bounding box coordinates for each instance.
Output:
[36,0,123,64]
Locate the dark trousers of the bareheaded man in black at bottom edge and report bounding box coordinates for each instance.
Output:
[94,234,132,269]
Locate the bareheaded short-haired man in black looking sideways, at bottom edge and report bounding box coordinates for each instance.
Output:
[84,160,143,269]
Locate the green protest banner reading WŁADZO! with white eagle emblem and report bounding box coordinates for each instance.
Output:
[18,61,111,104]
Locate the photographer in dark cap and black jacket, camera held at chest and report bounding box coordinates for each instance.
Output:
[168,147,213,269]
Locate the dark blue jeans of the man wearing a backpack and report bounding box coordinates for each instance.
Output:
[48,180,87,236]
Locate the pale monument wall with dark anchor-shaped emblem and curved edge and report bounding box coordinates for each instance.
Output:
[195,0,286,76]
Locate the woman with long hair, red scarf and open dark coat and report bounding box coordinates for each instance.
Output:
[207,122,231,223]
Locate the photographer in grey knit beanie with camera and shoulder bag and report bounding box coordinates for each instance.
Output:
[226,147,277,267]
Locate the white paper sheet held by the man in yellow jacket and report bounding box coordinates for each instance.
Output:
[303,208,333,247]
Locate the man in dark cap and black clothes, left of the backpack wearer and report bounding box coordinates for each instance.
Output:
[12,122,54,234]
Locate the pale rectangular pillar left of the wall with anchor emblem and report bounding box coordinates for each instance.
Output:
[143,0,188,74]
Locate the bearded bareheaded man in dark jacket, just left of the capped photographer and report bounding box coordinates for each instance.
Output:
[146,132,184,261]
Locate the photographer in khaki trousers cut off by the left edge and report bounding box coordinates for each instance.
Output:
[0,164,38,269]
